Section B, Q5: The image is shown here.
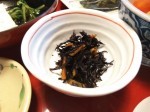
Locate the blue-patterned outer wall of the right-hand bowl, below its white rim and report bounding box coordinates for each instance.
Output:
[119,3,150,66]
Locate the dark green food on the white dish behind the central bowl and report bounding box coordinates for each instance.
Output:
[80,0,120,11]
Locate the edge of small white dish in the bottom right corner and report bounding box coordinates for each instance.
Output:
[133,96,150,112]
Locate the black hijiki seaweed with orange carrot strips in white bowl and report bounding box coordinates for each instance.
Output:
[50,31,113,88]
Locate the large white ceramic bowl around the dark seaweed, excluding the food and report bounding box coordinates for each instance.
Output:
[21,9,142,97]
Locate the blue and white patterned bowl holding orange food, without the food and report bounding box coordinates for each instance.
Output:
[119,0,150,66]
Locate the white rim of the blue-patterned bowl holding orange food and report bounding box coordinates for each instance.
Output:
[121,0,150,22]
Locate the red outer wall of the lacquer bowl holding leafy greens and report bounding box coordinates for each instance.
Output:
[0,0,58,48]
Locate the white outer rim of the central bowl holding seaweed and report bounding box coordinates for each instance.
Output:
[21,9,142,97]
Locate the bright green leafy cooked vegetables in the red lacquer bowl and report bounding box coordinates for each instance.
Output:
[8,0,45,25]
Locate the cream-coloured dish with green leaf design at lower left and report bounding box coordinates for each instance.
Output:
[0,57,31,112]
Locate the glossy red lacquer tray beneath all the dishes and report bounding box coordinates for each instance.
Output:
[0,2,150,112]
